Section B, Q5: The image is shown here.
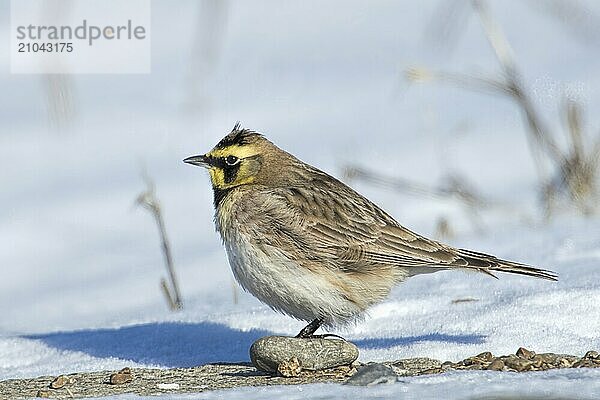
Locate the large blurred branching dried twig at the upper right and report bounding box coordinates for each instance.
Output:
[406,0,600,216]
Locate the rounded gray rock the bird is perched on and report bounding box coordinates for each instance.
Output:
[250,336,358,373]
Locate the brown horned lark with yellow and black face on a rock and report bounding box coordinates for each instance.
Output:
[183,122,558,338]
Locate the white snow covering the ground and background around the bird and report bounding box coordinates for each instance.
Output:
[0,0,600,399]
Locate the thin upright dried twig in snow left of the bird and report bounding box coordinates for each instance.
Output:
[136,175,183,310]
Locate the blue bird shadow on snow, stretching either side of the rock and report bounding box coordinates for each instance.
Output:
[24,322,485,367]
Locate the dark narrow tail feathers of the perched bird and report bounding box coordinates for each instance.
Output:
[458,249,558,281]
